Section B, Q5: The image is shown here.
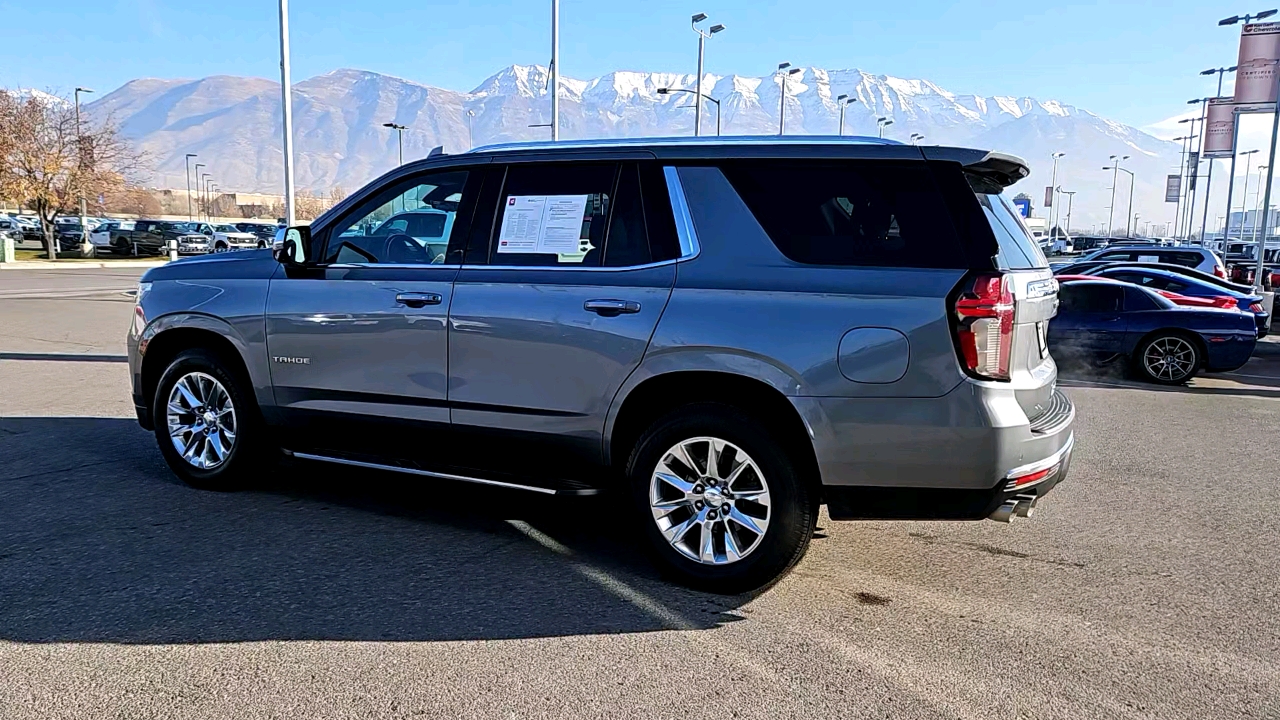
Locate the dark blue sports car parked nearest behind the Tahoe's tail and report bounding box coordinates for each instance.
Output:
[1047,278,1257,384]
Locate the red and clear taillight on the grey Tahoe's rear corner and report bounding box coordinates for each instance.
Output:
[955,270,1014,380]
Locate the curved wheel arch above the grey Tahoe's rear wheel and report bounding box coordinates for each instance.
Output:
[604,369,822,495]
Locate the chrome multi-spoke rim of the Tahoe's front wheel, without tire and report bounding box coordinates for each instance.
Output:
[165,373,238,470]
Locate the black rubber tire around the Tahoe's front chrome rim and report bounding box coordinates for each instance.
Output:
[152,348,279,491]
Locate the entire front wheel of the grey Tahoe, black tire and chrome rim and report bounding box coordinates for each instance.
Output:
[152,348,274,491]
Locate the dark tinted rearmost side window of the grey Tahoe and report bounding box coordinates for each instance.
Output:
[721,160,968,268]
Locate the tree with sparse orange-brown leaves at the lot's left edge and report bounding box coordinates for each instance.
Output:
[0,88,141,259]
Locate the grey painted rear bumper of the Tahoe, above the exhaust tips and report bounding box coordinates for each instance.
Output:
[791,382,1075,491]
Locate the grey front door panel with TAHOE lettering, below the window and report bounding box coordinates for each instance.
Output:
[266,266,457,452]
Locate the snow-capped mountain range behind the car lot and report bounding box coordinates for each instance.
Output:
[88,65,1179,228]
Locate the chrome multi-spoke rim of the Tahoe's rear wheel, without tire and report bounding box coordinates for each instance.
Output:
[649,437,771,565]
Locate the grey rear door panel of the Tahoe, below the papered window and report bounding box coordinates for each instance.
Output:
[449,264,676,474]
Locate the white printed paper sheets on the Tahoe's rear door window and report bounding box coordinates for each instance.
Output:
[497,195,590,255]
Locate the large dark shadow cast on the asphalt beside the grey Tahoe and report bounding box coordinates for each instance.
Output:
[0,418,748,643]
